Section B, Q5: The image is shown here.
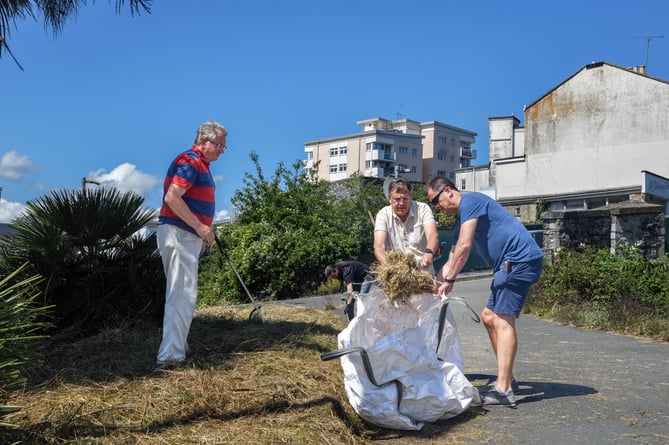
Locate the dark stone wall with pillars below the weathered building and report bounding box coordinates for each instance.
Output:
[541,200,665,262]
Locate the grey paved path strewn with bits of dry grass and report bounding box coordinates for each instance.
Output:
[278,277,669,445]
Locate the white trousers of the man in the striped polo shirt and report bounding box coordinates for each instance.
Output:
[157,224,202,363]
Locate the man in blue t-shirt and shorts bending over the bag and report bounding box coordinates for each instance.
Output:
[426,176,544,407]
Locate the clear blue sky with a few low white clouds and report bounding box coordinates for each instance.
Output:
[0,0,669,222]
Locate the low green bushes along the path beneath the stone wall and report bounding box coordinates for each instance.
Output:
[526,246,669,339]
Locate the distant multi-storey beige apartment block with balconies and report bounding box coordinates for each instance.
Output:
[304,118,476,182]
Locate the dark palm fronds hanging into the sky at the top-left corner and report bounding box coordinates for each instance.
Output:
[0,0,153,70]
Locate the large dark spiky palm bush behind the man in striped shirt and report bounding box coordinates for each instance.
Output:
[0,187,164,328]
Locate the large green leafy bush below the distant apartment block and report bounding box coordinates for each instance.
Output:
[200,153,384,304]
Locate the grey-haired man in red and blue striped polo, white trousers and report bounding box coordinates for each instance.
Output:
[157,121,228,365]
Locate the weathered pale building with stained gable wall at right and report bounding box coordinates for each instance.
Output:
[456,62,669,222]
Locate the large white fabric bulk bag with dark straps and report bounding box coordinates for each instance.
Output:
[324,288,480,430]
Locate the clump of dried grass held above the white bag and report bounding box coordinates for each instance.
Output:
[374,250,434,302]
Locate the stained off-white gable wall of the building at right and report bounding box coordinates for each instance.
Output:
[504,63,669,200]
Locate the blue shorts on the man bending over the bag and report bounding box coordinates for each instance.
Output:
[486,258,544,318]
